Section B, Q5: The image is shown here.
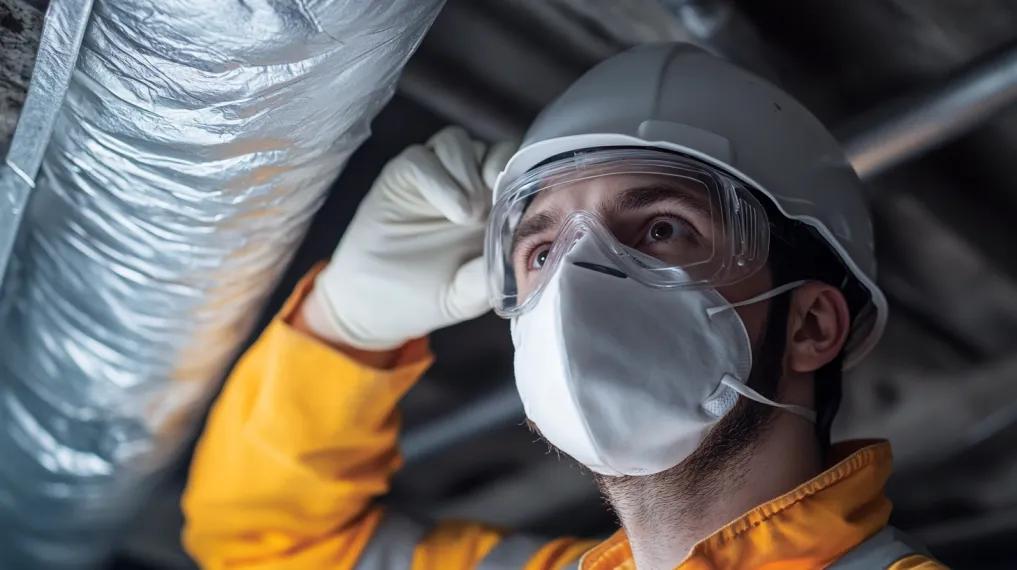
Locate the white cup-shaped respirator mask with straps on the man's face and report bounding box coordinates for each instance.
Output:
[512,233,816,475]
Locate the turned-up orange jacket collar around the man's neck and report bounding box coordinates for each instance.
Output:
[580,441,892,570]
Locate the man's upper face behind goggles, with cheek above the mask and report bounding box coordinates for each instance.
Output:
[512,169,771,350]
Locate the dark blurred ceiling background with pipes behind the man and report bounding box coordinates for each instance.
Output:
[0,0,1017,570]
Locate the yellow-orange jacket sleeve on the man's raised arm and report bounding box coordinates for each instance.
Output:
[183,276,431,570]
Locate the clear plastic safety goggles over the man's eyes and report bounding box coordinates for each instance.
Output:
[485,149,770,318]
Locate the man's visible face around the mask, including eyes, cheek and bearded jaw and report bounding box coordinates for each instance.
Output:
[512,169,780,494]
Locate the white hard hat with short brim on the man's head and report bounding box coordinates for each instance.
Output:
[494,43,887,367]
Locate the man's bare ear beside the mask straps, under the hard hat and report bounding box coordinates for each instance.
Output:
[786,281,851,374]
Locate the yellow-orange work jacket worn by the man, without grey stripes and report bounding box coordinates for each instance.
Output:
[183,278,942,570]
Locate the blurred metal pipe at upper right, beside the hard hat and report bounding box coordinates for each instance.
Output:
[838,45,1017,178]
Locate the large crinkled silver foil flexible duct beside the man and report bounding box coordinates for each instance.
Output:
[0,0,442,568]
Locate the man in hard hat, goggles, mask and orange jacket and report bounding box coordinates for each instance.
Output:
[184,44,941,570]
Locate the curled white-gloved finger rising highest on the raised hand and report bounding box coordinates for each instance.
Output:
[427,126,490,222]
